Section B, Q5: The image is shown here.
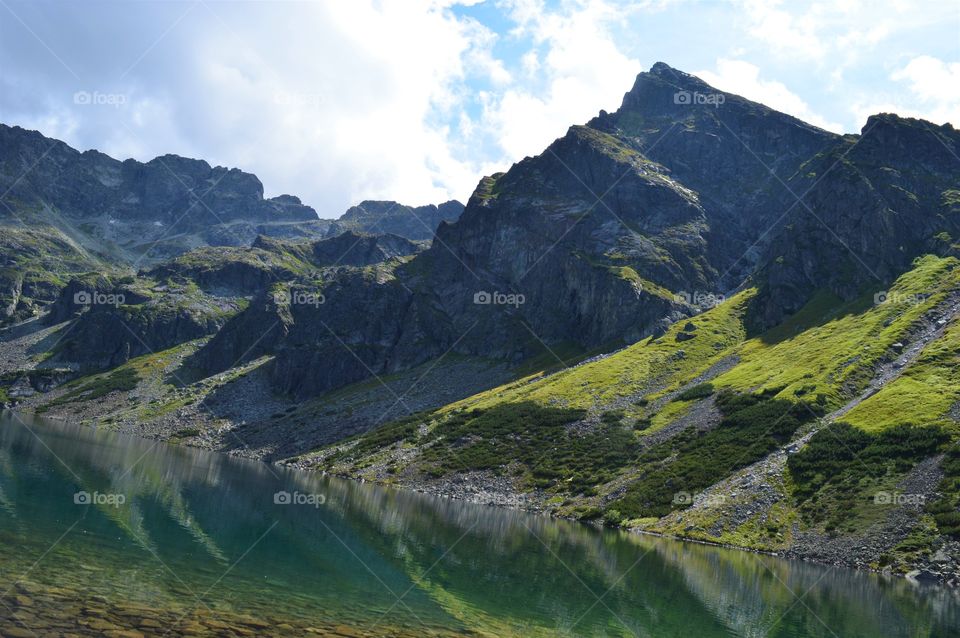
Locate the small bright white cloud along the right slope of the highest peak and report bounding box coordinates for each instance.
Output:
[694,58,843,133]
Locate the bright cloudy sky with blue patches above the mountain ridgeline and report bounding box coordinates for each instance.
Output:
[0,0,960,218]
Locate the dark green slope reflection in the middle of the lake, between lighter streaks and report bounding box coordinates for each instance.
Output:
[312,481,740,636]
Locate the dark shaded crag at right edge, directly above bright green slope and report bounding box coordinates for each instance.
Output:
[755,114,960,325]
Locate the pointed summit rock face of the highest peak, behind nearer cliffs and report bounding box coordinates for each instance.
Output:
[589,62,841,292]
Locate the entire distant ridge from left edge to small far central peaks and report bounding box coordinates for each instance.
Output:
[0,124,463,323]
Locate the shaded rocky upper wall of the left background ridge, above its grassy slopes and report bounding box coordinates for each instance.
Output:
[0,125,327,264]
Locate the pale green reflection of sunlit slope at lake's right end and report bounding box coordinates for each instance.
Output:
[654,528,960,638]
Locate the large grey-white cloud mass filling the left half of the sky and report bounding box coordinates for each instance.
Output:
[0,0,512,216]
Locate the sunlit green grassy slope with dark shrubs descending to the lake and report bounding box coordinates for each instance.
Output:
[318,256,960,586]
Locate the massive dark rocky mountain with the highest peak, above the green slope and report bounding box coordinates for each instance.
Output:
[139,64,960,398]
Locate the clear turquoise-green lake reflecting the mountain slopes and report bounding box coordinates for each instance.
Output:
[0,413,960,638]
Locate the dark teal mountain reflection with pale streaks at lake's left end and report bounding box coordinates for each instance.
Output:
[0,416,468,632]
